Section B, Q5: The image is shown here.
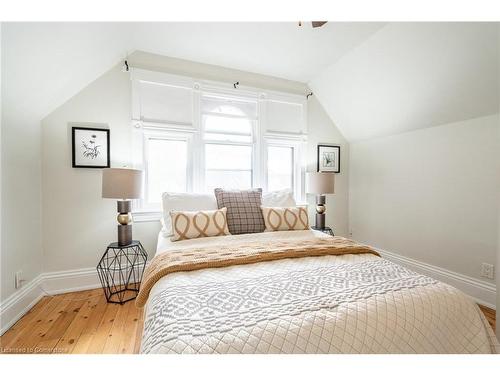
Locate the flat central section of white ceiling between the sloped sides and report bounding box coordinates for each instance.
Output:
[133,22,384,83]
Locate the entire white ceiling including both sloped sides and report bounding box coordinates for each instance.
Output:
[2,22,499,141]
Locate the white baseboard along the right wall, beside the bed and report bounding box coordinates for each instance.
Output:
[372,246,496,309]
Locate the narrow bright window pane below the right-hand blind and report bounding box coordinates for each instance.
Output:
[267,146,294,191]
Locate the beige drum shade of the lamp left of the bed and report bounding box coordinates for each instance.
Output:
[102,168,142,199]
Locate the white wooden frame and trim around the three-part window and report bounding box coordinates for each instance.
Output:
[131,69,307,221]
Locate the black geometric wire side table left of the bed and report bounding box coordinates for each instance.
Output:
[97,241,148,305]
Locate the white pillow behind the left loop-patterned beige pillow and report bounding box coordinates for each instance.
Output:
[161,193,217,237]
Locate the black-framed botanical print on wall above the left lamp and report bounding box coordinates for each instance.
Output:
[71,126,110,168]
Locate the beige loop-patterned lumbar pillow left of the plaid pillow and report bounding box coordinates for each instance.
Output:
[170,207,230,241]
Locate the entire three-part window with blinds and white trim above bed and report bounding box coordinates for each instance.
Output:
[132,69,307,220]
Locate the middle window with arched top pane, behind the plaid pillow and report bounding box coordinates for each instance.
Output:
[201,96,257,192]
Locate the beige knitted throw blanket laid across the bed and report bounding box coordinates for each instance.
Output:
[136,237,379,307]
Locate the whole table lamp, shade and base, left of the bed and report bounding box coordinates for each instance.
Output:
[102,168,142,246]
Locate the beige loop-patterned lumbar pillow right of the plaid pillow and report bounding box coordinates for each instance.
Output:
[261,207,309,232]
